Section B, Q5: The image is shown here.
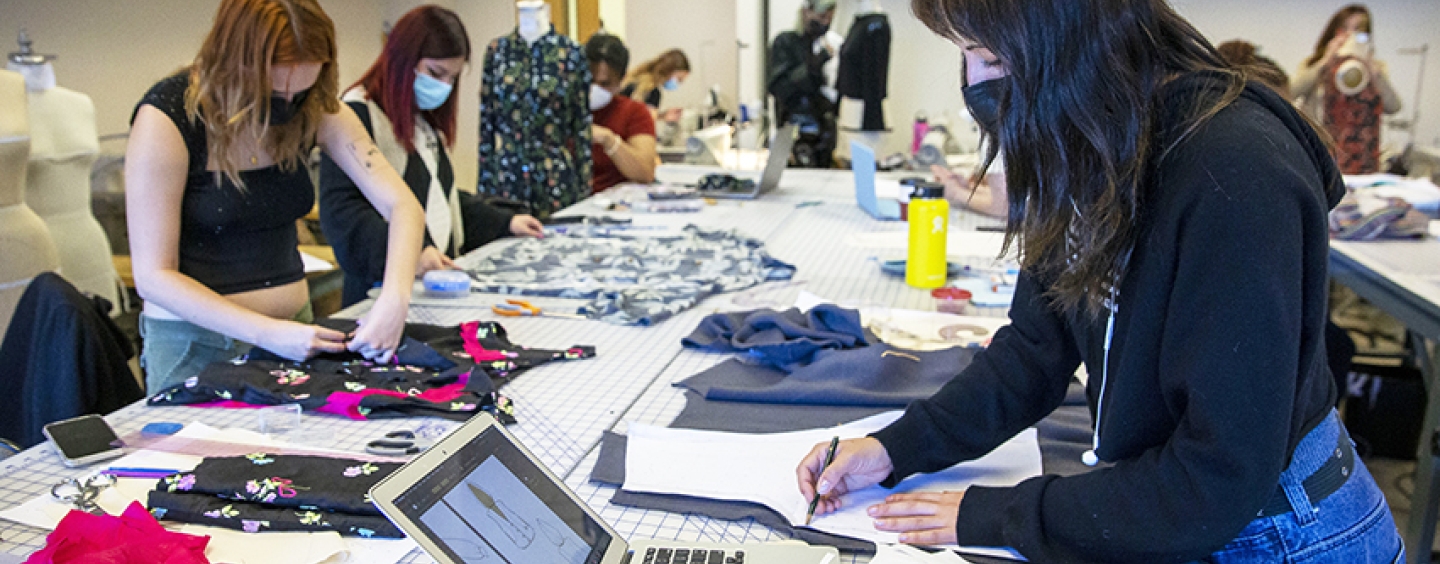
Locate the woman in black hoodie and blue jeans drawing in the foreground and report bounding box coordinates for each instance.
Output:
[796,0,1403,563]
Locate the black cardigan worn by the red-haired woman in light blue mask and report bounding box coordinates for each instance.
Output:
[320,102,514,306]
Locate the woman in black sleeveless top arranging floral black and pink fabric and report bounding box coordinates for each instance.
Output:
[125,0,425,393]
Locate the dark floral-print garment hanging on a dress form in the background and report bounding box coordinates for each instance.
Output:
[477,29,593,219]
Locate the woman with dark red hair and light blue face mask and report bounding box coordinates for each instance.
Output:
[320,4,543,305]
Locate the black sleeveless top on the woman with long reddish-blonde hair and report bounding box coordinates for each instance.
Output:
[130,72,315,294]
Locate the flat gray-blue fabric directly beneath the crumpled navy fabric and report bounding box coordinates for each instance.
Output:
[680,344,979,409]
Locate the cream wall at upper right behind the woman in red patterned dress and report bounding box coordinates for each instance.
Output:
[1172,0,1440,153]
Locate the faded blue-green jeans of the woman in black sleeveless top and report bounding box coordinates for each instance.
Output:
[140,302,315,394]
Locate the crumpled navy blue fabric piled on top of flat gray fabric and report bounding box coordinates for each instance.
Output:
[680,304,878,373]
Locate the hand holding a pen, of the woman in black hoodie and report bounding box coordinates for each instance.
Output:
[795,437,887,517]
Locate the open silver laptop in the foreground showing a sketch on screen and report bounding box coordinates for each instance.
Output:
[370,414,840,564]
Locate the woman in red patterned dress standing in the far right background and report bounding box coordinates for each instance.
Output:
[1290,4,1400,174]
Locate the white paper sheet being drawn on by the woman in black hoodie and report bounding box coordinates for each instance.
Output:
[622,411,1041,544]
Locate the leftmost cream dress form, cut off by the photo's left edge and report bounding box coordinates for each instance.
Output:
[0,71,60,341]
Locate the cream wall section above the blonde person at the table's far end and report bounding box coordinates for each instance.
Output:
[624,0,739,109]
